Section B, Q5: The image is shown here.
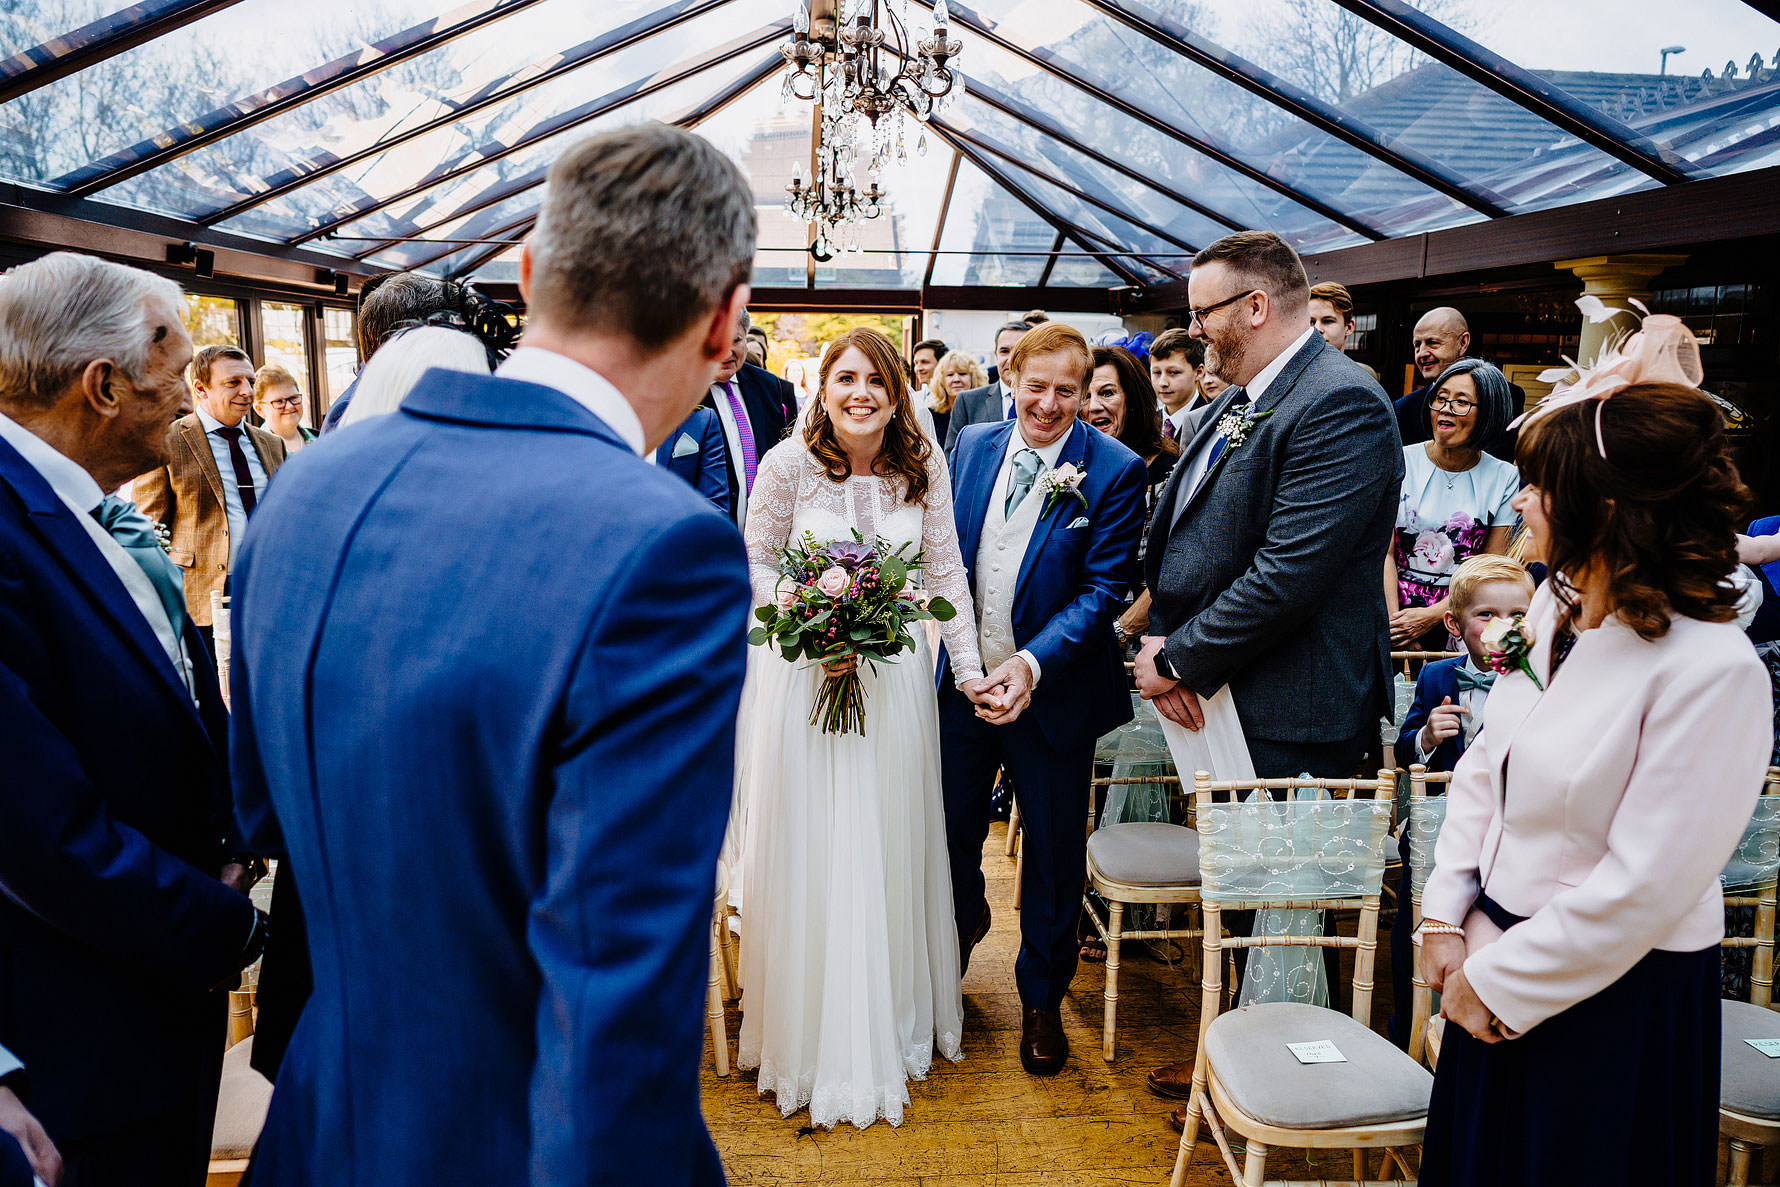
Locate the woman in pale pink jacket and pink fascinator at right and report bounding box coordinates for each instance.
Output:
[1420,317,1773,1187]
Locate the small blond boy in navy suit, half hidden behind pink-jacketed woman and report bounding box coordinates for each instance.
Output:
[1390,553,1533,1045]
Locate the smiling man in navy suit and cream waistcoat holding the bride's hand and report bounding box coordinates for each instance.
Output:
[940,322,1146,1075]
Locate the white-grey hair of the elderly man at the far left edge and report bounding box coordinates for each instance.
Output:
[0,251,185,408]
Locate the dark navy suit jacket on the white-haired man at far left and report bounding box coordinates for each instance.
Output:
[0,441,253,1143]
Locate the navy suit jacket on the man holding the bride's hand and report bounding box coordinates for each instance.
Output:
[940,420,1150,751]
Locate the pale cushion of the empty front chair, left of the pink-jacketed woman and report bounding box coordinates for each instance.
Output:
[1205,1002,1435,1130]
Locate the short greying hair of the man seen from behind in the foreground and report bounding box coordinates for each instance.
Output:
[530,123,758,351]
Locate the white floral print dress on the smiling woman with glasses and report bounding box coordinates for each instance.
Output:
[1394,445,1520,609]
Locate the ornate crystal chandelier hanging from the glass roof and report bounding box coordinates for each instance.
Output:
[780,0,965,260]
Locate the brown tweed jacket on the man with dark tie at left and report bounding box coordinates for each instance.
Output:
[130,413,285,626]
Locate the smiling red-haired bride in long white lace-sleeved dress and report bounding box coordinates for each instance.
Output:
[737,329,983,1128]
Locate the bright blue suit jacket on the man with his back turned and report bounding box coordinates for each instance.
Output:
[230,370,749,1187]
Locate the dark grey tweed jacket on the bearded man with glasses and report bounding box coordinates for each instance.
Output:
[1145,335,1403,742]
